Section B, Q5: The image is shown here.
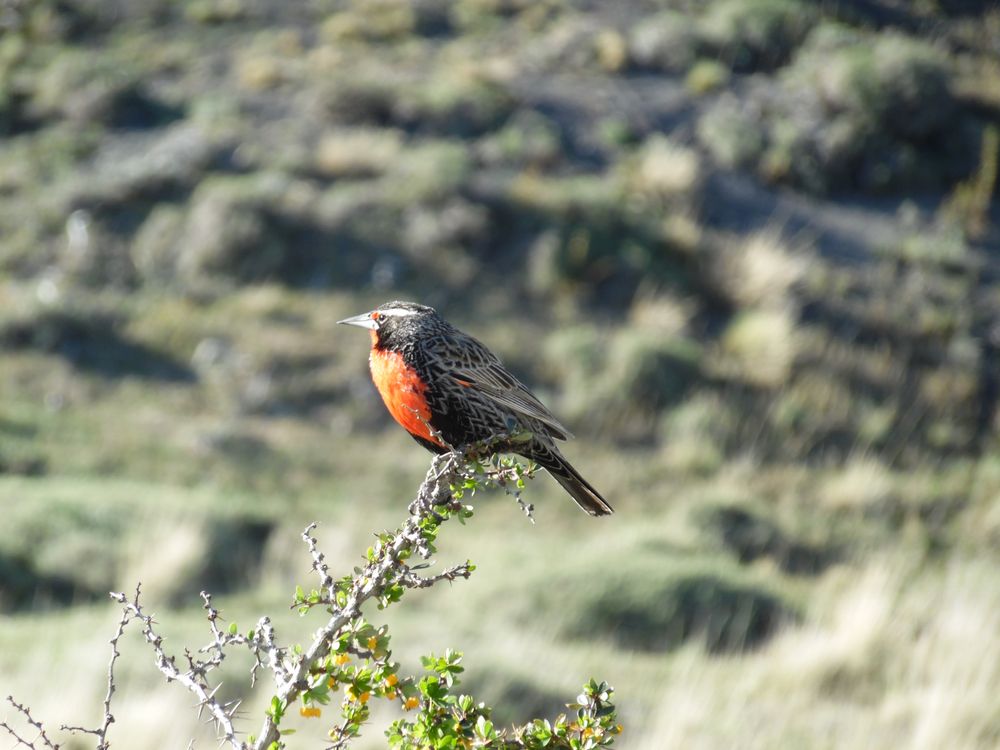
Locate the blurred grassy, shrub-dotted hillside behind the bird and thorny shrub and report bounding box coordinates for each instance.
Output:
[0,0,1000,750]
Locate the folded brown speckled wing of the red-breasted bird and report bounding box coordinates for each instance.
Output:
[426,334,573,440]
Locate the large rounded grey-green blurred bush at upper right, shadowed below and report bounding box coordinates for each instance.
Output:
[697,24,977,193]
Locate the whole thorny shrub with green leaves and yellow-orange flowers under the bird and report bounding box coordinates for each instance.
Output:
[0,452,622,750]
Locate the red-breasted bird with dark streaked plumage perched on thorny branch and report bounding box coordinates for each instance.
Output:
[337,301,614,516]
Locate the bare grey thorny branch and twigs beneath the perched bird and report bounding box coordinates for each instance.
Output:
[0,444,516,750]
